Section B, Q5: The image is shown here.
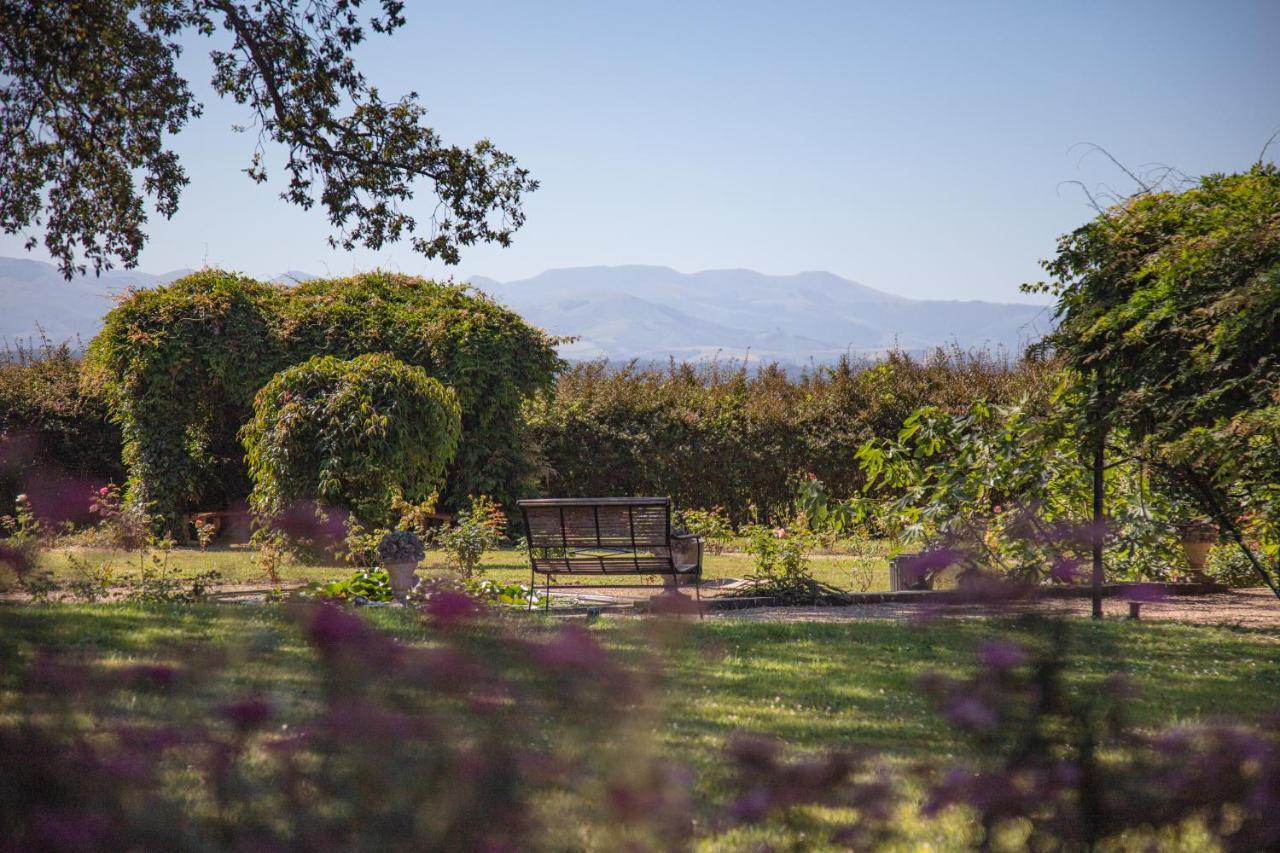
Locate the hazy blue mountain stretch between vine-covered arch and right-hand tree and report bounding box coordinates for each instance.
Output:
[471,266,1050,362]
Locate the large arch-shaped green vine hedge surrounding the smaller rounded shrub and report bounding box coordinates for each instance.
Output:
[84,270,561,528]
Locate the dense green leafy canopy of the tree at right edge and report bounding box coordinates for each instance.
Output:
[1030,163,1280,589]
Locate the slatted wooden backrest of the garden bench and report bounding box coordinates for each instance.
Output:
[520,497,675,574]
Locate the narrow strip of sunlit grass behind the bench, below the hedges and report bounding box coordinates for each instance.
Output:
[30,543,888,590]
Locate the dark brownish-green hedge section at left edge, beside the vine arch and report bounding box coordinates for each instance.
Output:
[0,341,124,512]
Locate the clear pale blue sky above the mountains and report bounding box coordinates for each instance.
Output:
[0,0,1280,301]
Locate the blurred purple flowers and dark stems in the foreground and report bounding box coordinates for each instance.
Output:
[0,598,1280,850]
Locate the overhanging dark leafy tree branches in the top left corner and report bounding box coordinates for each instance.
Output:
[0,0,538,278]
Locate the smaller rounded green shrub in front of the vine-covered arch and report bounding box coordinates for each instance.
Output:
[241,353,462,526]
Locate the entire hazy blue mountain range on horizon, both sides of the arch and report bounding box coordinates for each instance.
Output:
[0,257,1050,364]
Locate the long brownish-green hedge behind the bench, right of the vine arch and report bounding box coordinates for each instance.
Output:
[526,351,1051,526]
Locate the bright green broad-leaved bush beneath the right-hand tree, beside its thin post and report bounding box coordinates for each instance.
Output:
[858,394,1181,581]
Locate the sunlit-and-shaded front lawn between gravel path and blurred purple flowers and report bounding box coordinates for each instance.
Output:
[0,605,1280,849]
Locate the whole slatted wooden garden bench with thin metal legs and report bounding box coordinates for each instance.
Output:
[518,497,703,607]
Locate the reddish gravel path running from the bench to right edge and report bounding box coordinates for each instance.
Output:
[710,588,1280,631]
